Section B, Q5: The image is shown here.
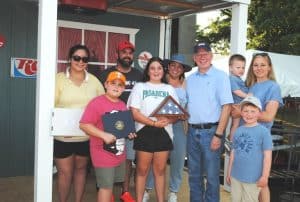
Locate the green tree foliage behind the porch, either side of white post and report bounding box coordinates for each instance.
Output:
[196,0,300,55]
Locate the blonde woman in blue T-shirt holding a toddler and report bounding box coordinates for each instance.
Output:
[233,53,283,202]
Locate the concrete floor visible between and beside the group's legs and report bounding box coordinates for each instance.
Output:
[0,166,230,202]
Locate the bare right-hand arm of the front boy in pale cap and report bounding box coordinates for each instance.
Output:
[256,150,272,187]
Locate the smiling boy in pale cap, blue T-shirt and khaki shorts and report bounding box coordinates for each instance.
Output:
[226,96,272,202]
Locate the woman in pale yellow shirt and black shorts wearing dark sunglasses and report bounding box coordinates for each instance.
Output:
[54,45,104,202]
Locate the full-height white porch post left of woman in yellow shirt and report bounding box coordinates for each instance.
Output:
[34,0,57,202]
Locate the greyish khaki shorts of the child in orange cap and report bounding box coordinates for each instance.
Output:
[95,161,125,189]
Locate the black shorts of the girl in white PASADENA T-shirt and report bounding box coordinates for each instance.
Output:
[133,126,173,152]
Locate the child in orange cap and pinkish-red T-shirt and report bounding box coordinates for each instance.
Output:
[80,71,135,202]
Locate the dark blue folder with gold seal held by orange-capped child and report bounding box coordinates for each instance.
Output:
[102,110,135,139]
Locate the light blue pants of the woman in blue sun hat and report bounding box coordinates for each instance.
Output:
[146,121,187,193]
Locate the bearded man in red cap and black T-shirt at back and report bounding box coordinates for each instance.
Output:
[97,40,142,202]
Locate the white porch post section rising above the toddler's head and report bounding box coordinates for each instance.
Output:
[230,3,248,54]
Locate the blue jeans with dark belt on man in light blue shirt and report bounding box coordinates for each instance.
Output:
[187,126,222,202]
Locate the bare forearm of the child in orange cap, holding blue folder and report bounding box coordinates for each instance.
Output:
[79,123,116,144]
